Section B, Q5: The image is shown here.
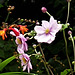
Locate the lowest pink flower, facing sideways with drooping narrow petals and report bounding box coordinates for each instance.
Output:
[19,54,32,73]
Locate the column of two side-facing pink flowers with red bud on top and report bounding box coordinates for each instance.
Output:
[9,28,32,72]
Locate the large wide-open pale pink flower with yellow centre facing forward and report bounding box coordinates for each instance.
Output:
[34,16,62,44]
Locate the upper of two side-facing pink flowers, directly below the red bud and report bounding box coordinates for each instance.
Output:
[15,34,28,54]
